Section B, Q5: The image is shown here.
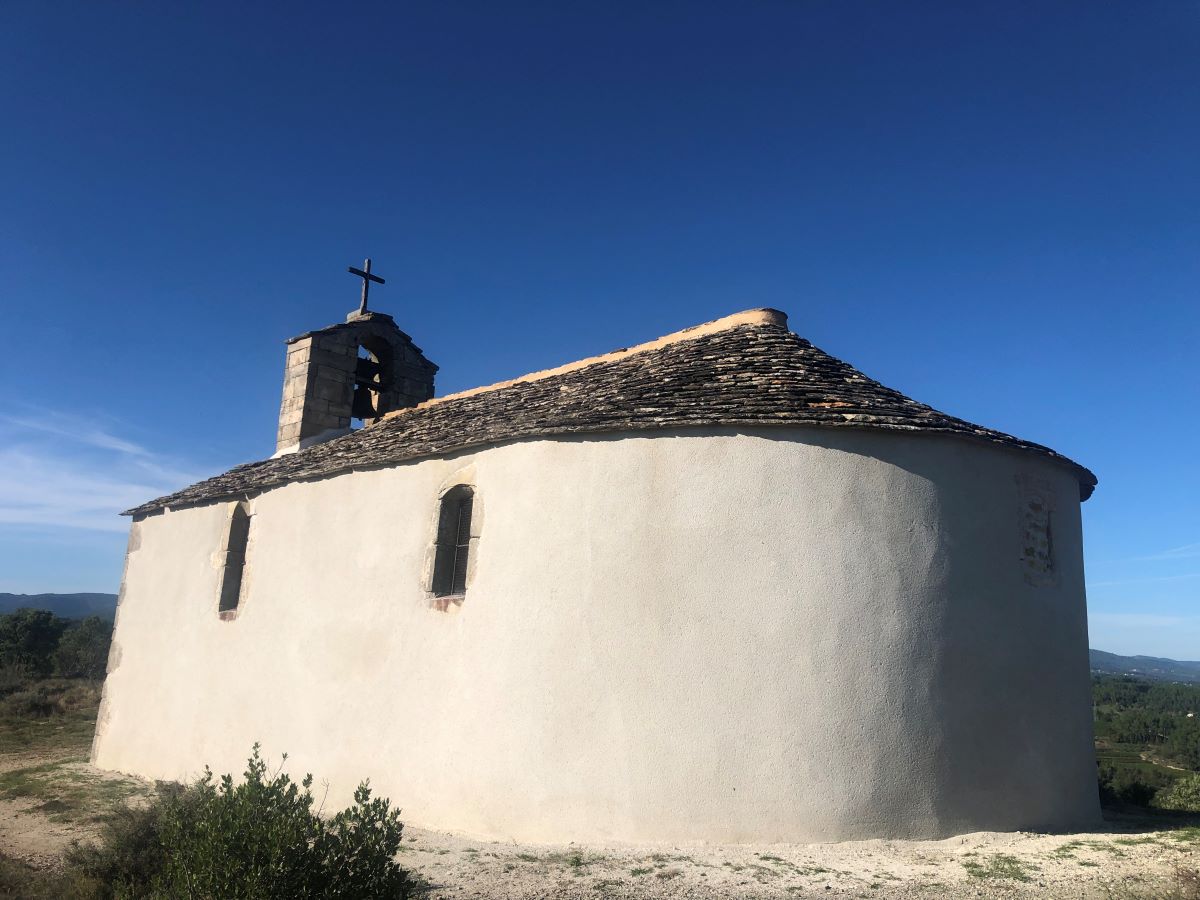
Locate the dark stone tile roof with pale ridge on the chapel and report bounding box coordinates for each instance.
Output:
[125,310,1096,516]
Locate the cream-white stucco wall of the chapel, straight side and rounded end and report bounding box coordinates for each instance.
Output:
[94,428,1098,841]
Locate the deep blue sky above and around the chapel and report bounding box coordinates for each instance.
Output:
[0,0,1200,659]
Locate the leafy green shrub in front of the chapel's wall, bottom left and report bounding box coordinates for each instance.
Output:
[68,744,412,900]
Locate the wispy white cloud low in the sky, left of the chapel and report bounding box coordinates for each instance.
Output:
[0,413,196,532]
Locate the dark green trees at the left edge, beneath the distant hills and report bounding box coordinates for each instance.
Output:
[0,610,113,680]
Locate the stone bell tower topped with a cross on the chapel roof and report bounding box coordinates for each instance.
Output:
[275,259,438,456]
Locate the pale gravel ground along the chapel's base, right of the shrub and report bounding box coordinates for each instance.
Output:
[403,818,1200,900]
